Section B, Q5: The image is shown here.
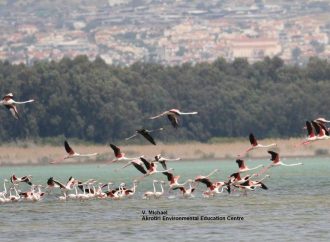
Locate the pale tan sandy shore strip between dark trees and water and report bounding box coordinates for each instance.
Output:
[0,138,330,165]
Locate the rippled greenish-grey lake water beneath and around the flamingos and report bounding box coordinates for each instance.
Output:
[0,158,330,241]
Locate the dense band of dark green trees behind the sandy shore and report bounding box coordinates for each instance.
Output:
[0,56,330,143]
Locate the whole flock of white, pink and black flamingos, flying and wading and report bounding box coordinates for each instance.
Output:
[0,93,330,203]
